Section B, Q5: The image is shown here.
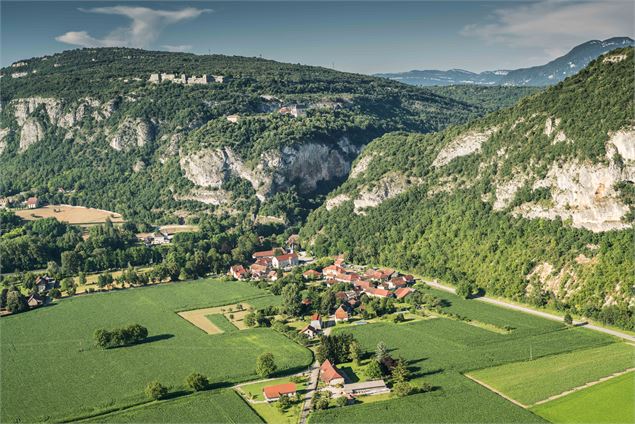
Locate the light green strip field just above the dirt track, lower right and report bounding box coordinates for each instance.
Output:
[470,343,635,405]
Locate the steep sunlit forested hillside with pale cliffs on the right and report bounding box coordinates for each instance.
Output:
[301,49,635,329]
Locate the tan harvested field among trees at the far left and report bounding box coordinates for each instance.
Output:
[15,205,124,225]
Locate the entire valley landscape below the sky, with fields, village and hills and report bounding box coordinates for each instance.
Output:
[0,21,635,424]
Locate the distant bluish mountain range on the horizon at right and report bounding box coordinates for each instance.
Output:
[376,37,633,86]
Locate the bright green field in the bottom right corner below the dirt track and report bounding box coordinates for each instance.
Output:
[532,372,635,424]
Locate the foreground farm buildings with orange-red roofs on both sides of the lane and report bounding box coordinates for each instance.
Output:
[262,359,390,402]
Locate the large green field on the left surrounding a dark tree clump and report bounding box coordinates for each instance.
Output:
[0,280,311,422]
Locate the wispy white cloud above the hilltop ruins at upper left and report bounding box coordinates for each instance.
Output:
[55,6,211,48]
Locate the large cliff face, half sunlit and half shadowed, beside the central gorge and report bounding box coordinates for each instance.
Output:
[180,140,355,201]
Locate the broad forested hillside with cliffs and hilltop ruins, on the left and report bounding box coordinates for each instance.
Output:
[0,48,483,223]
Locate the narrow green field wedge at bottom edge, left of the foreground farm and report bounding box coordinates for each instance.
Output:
[86,390,263,424]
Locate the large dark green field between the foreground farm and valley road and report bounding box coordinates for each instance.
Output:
[310,291,614,423]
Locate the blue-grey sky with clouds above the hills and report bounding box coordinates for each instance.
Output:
[0,0,635,74]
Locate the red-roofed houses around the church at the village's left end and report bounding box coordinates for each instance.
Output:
[229,248,300,281]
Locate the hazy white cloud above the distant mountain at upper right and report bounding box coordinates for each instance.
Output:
[462,0,635,58]
